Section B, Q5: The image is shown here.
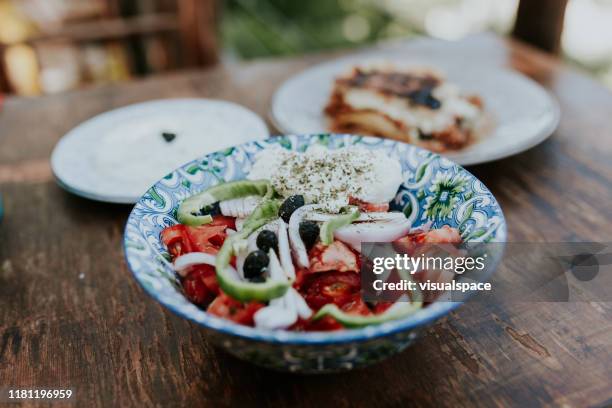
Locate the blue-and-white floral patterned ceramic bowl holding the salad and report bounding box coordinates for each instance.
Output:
[124,134,506,373]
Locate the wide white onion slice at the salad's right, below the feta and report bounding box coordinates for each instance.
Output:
[334,218,412,251]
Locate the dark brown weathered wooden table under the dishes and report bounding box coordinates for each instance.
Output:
[0,36,612,407]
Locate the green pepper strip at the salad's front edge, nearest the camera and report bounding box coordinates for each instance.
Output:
[312,301,423,328]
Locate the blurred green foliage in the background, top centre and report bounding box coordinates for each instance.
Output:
[221,0,413,59]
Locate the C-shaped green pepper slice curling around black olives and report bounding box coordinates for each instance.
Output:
[215,200,292,302]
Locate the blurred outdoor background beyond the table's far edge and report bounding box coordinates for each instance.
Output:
[0,0,612,96]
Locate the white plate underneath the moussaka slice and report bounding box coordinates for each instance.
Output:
[270,52,559,165]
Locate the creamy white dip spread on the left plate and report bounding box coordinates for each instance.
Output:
[91,110,256,194]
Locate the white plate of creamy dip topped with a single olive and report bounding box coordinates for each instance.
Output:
[51,99,269,204]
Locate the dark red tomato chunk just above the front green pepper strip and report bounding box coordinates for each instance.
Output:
[300,271,361,310]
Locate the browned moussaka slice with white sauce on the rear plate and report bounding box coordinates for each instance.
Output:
[325,66,483,152]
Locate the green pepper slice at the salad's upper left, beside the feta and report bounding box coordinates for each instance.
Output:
[177,180,273,226]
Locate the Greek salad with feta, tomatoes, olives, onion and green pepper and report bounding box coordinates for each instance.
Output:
[161,146,461,331]
